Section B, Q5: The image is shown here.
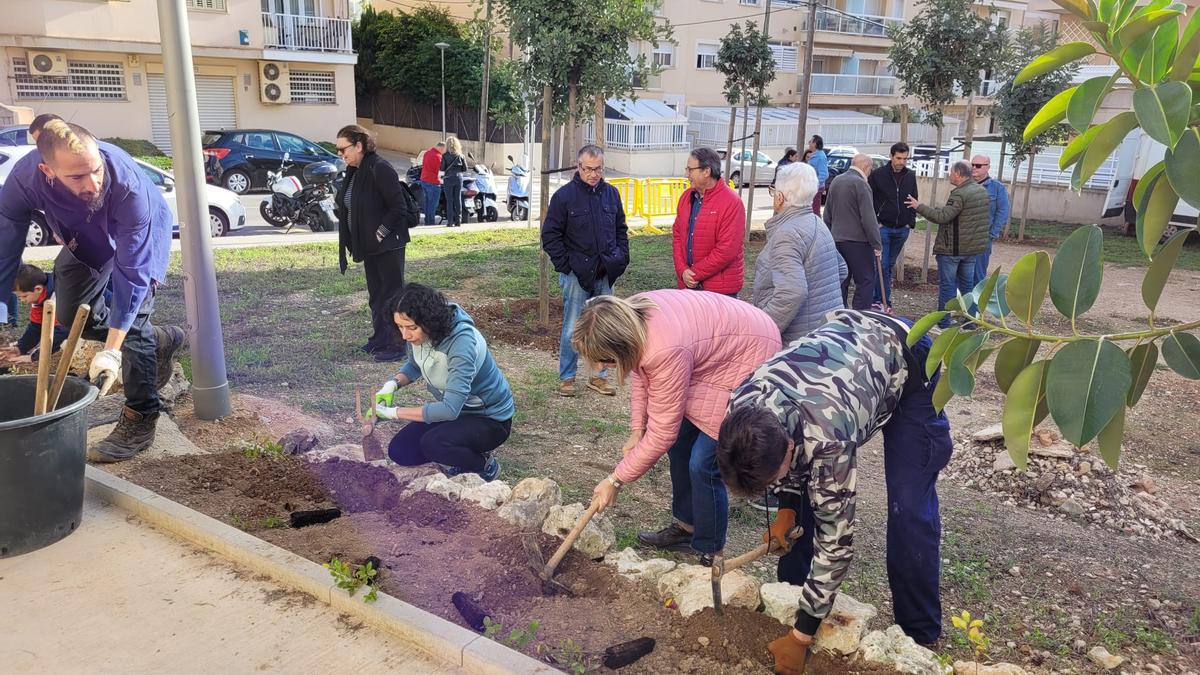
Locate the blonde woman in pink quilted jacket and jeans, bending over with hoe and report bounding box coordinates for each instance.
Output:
[571,289,780,557]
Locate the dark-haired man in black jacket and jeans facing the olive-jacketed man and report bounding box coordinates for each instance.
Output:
[866,143,918,306]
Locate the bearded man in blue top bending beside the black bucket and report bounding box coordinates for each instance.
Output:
[0,120,185,461]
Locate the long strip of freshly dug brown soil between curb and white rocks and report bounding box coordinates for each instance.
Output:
[127,454,890,675]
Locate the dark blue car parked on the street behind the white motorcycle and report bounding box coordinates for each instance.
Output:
[202,129,346,195]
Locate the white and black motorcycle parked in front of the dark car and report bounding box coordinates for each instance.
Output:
[258,153,340,232]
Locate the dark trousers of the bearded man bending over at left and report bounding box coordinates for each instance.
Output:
[54,246,162,413]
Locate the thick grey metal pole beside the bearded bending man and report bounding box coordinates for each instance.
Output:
[158,0,233,419]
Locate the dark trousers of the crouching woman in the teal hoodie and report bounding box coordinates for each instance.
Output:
[388,414,512,472]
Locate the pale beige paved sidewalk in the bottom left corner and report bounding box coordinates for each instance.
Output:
[0,487,460,674]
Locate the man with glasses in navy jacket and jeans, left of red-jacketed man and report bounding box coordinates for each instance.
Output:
[541,145,629,396]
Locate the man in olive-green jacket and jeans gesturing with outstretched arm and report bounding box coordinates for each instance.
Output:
[906,160,988,327]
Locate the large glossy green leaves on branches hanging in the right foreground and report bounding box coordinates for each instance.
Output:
[908,0,1200,470]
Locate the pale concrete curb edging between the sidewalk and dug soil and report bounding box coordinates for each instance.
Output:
[84,466,558,675]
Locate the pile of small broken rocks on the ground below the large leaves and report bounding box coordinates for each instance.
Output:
[944,424,1192,538]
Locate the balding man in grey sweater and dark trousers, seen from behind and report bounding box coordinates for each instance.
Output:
[823,154,881,310]
